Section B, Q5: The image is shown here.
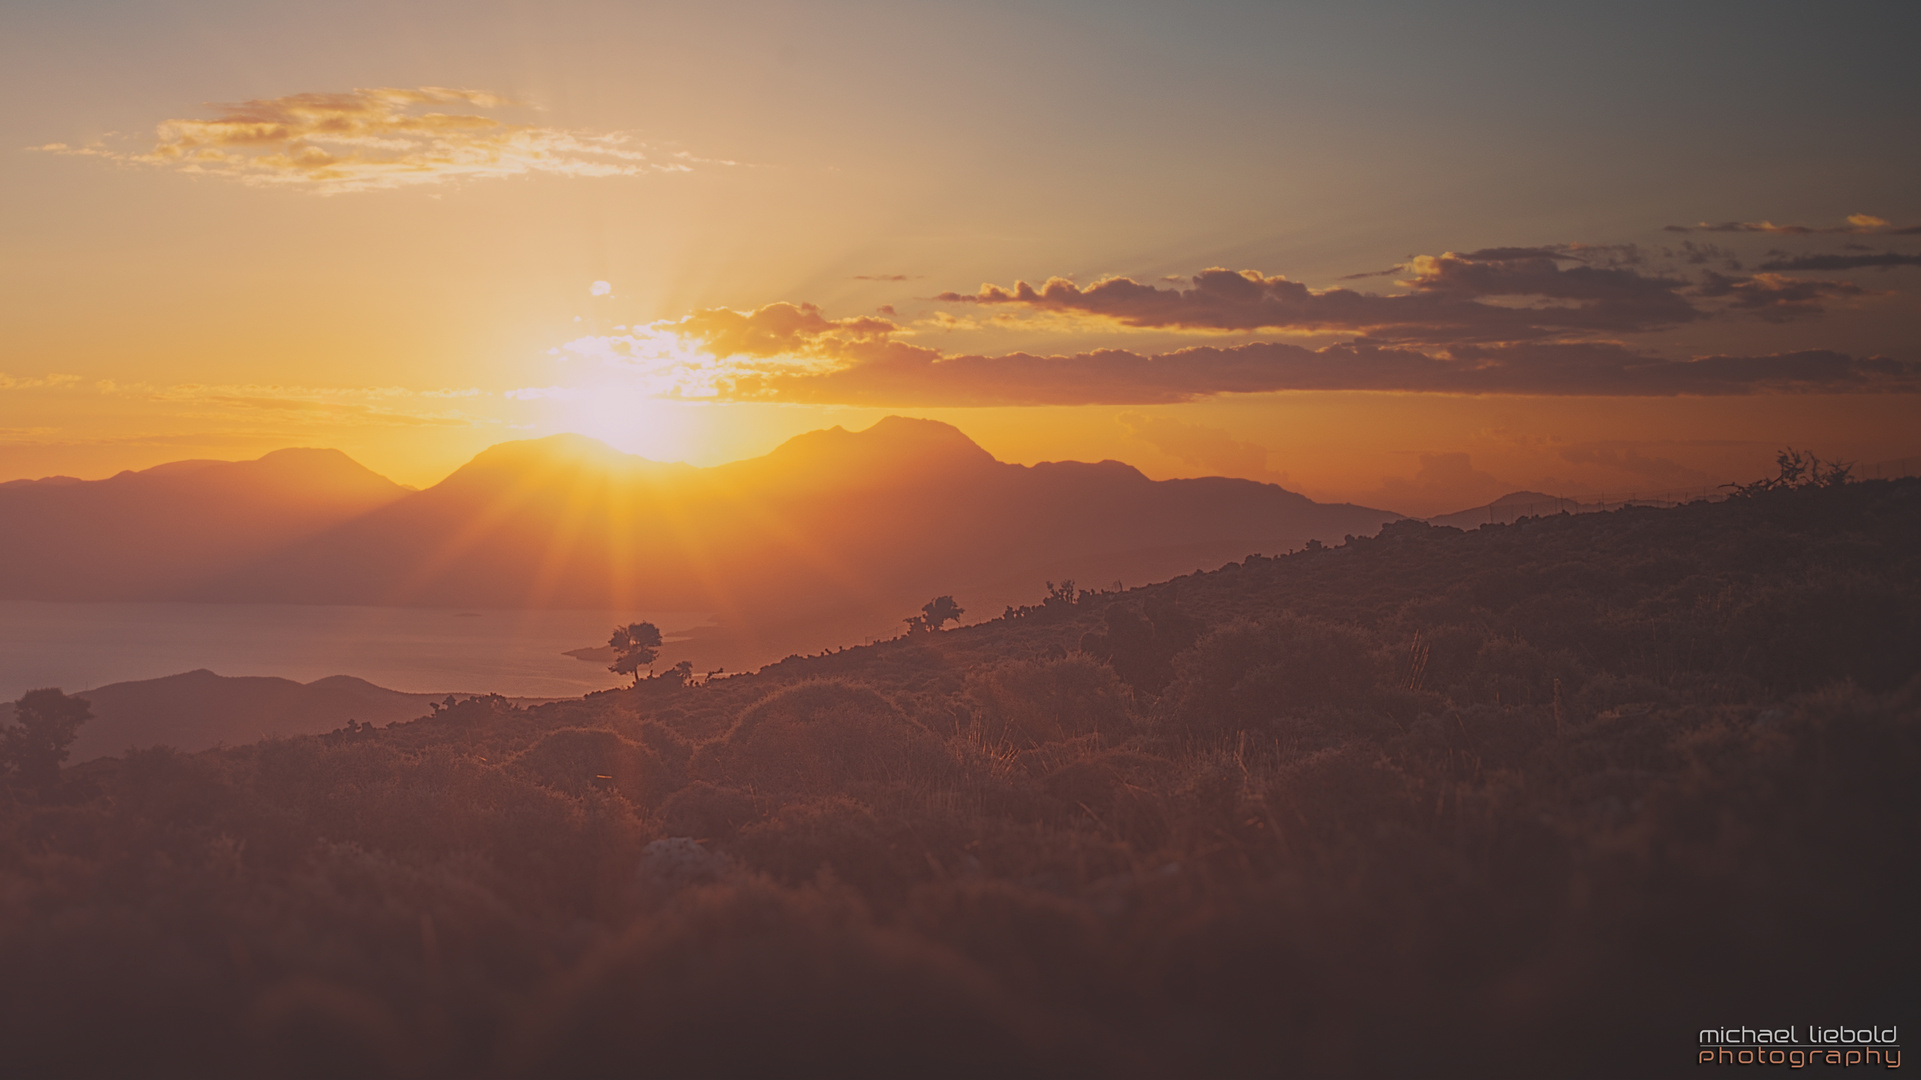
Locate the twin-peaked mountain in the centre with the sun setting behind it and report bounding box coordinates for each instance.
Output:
[194,417,1398,623]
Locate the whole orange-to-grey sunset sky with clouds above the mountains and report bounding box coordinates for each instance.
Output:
[0,0,1921,513]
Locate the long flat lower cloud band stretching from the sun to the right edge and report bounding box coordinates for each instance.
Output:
[549,286,1921,407]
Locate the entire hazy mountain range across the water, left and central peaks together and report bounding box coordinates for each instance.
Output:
[0,417,1400,663]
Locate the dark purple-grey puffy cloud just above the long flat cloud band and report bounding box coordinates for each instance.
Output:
[936,248,1702,342]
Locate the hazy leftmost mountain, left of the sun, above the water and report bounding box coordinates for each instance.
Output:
[0,450,407,600]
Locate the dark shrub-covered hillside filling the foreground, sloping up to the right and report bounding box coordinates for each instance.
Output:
[0,474,1921,1076]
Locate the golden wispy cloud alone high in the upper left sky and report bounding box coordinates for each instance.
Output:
[38,86,717,194]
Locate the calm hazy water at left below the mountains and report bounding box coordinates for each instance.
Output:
[0,600,709,703]
